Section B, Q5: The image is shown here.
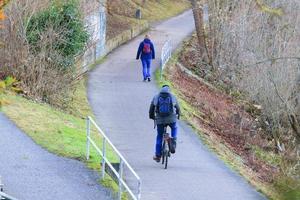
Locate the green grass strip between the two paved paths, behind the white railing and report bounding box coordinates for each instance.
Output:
[0,74,127,196]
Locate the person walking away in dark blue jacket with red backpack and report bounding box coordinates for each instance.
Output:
[136,35,155,81]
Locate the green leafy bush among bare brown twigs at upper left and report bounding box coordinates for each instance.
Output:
[26,0,88,68]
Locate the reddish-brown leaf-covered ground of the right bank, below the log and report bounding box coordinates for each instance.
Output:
[170,65,275,182]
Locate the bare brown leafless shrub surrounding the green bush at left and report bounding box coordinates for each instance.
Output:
[0,0,88,107]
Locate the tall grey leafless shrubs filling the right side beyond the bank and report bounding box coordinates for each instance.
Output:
[192,0,300,177]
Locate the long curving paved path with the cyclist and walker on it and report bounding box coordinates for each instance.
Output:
[88,11,265,200]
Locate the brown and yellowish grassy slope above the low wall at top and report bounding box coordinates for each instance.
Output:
[107,0,190,39]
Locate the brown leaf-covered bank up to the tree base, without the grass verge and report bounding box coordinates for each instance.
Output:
[166,36,277,183]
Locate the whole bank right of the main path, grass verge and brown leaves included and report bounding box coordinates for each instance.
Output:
[165,35,300,200]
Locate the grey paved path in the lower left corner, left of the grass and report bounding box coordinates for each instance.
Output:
[0,113,111,200]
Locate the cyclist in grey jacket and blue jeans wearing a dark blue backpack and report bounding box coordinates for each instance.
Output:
[149,85,180,162]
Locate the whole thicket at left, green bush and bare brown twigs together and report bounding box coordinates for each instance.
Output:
[0,0,89,107]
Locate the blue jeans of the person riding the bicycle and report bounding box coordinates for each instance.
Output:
[155,122,177,156]
